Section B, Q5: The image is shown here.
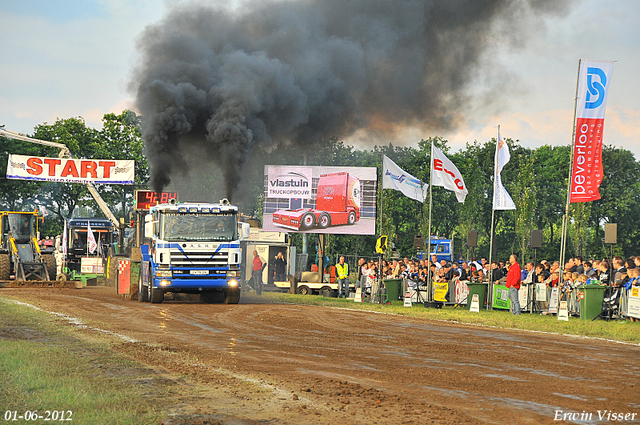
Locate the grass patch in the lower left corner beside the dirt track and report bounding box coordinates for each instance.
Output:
[0,300,165,424]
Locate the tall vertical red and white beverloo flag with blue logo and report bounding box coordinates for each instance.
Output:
[569,60,614,202]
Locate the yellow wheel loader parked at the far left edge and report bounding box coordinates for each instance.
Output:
[0,211,57,281]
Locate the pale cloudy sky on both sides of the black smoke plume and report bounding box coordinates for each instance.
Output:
[0,0,640,158]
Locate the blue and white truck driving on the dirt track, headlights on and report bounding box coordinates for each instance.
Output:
[138,199,249,304]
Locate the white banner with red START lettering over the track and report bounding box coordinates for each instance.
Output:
[7,155,135,184]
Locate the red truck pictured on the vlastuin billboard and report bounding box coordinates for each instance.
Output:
[273,172,362,231]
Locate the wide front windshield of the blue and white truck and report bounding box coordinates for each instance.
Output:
[160,213,238,241]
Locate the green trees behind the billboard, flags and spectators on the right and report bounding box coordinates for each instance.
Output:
[253,137,640,259]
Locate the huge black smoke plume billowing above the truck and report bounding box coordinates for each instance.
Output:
[131,0,566,198]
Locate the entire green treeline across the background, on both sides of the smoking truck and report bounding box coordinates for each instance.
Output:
[0,111,640,259]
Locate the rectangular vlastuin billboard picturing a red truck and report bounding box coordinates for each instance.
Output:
[262,165,378,235]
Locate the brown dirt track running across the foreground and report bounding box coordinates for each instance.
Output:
[0,287,640,424]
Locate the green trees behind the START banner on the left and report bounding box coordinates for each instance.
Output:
[0,111,149,236]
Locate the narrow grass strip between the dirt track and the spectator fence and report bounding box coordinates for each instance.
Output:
[249,292,640,344]
